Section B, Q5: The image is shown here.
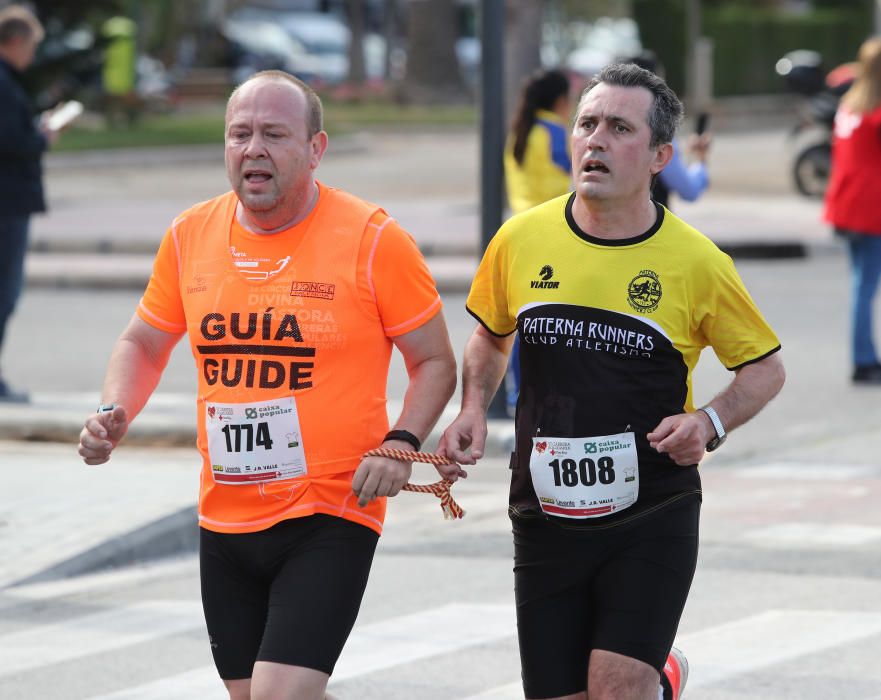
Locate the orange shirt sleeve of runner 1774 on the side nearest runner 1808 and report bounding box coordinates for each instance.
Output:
[359,212,442,337]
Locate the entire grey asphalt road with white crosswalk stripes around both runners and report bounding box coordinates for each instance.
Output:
[0,254,881,700]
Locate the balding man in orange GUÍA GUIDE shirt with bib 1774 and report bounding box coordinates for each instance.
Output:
[79,71,456,700]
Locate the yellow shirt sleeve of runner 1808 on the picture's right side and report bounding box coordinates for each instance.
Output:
[694,251,780,370]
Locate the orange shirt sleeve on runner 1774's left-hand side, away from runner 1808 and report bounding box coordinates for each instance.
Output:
[138,226,187,333]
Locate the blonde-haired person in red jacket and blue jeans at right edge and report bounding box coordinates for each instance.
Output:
[824,37,881,384]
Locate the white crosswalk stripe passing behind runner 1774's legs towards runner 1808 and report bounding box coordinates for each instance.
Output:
[91,603,516,700]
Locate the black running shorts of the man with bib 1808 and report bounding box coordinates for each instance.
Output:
[513,498,700,698]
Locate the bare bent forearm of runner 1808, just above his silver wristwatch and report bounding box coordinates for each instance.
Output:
[707,352,786,431]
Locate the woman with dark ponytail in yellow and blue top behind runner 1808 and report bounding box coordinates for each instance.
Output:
[505,70,572,214]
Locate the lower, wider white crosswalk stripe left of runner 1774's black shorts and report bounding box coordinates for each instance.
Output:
[0,600,205,676]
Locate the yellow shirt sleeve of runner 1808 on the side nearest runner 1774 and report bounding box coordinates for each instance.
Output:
[465,226,517,337]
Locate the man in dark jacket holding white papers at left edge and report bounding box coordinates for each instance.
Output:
[0,5,57,402]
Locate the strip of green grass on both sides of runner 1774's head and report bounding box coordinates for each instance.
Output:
[53,100,478,152]
